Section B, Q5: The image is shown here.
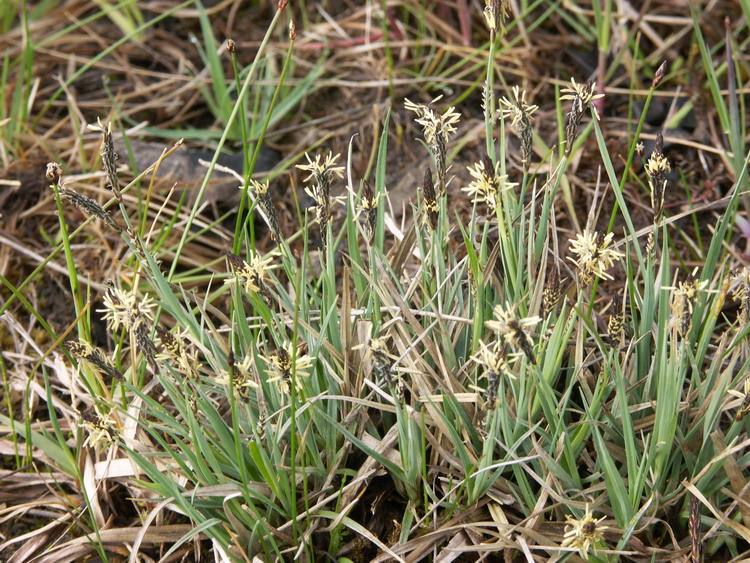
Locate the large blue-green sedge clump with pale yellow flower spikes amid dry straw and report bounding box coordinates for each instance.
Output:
[0,2,750,561]
